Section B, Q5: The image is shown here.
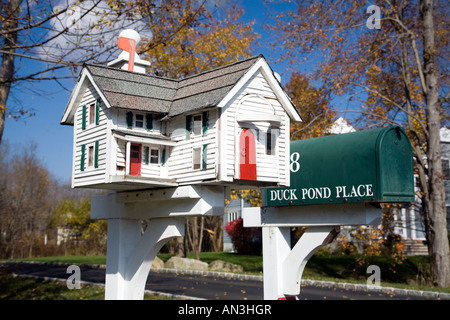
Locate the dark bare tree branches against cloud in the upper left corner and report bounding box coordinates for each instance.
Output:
[0,0,110,142]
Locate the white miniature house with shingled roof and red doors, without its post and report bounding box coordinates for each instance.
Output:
[61,31,301,190]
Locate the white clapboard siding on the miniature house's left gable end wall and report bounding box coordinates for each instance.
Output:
[73,85,108,187]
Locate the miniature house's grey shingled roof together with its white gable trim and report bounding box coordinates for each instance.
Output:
[61,55,300,124]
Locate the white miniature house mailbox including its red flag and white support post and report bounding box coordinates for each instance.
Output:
[61,30,301,299]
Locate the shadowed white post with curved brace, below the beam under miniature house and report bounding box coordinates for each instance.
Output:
[105,217,184,300]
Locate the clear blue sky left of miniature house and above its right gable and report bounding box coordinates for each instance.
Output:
[3,0,302,183]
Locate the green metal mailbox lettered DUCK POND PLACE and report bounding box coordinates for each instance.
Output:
[262,126,414,206]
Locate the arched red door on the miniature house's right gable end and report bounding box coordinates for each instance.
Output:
[239,129,256,181]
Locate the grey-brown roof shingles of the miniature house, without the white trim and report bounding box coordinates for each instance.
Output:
[85,55,262,117]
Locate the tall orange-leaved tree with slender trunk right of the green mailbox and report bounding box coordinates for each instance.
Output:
[272,0,450,287]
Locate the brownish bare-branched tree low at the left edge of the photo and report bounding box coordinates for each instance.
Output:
[0,144,53,258]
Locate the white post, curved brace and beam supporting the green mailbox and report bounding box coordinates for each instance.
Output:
[243,203,381,300]
